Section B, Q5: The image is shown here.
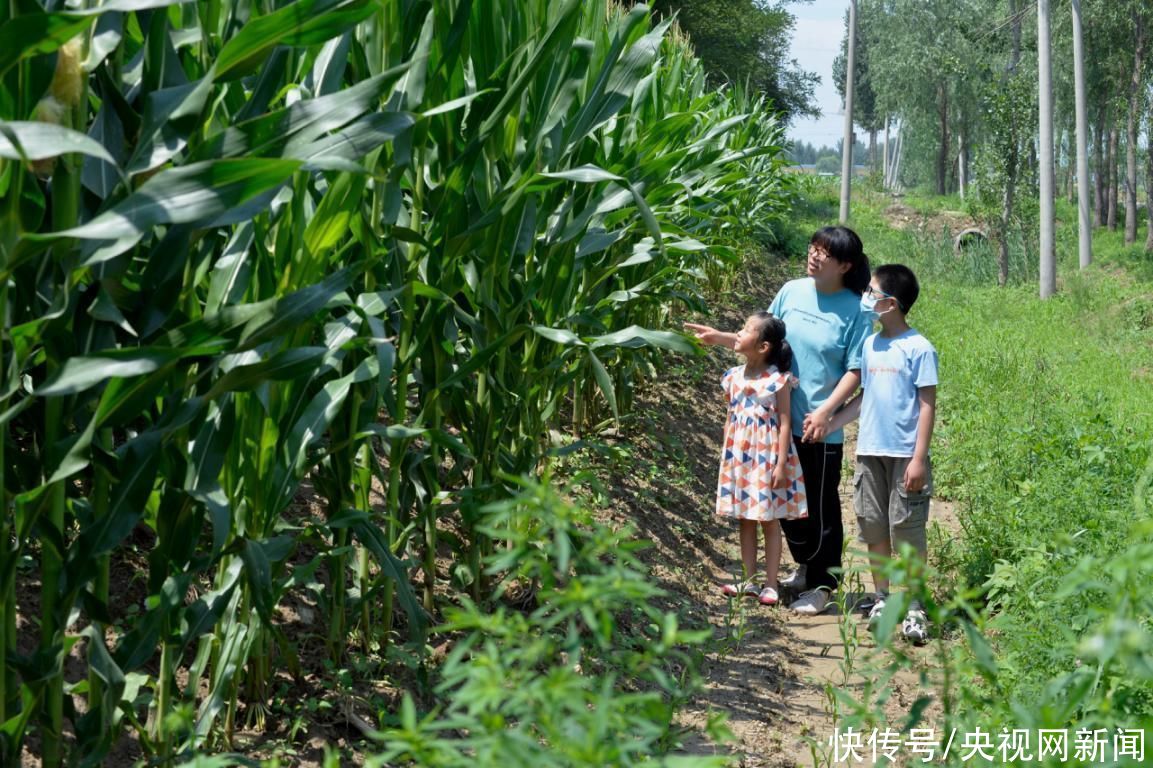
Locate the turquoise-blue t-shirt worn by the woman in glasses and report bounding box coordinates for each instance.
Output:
[769,278,873,443]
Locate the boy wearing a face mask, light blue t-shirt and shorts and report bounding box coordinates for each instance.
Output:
[830,264,937,645]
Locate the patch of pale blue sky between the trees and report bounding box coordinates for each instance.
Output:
[789,0,849,146]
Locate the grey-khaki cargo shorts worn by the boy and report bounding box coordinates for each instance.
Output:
[853,455,933,557]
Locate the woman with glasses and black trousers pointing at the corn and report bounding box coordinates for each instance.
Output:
[685,226,872,615]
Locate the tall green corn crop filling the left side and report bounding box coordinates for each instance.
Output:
[0,0,787,767]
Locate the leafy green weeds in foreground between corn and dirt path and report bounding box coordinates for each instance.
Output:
[368,482,726,768]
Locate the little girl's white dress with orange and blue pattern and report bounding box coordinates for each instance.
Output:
[717,366,808,520]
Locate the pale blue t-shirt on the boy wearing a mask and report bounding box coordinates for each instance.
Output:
[857,329,937,457]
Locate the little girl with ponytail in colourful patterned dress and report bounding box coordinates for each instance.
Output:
[717,313,808,605]
